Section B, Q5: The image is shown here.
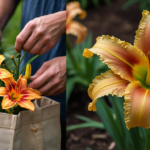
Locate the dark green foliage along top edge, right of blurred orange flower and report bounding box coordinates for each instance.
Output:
[67,0,111,9]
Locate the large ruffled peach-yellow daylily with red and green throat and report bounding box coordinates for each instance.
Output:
[83,10,150,129]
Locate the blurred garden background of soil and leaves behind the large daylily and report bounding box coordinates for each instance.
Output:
[67,0,150,150]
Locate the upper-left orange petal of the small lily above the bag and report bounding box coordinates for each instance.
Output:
[2,76,16,91]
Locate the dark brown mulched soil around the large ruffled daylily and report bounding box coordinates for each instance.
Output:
[67,0,141,150]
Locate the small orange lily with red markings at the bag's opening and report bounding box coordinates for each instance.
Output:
[0,69,41,111]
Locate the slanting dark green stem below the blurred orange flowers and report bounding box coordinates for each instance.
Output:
[66,35,84,77]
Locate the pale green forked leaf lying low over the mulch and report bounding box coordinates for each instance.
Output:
[67,115,104,131]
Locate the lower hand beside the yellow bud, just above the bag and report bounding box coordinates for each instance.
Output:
[29,56,66,96]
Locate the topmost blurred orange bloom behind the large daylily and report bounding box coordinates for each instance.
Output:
[66,2,86,25]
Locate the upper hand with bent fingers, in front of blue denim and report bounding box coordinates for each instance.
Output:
[15,11,66,55]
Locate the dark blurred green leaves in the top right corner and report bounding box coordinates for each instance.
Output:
[122,0,150,11]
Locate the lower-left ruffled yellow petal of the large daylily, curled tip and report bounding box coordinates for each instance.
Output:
[88,70,129,111]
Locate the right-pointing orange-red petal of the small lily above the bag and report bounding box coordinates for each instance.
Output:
[20,88,41,100]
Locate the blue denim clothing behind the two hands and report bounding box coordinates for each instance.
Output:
[20,0,66,121]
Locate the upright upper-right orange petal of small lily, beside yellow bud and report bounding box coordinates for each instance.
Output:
[17,75,27,90]
